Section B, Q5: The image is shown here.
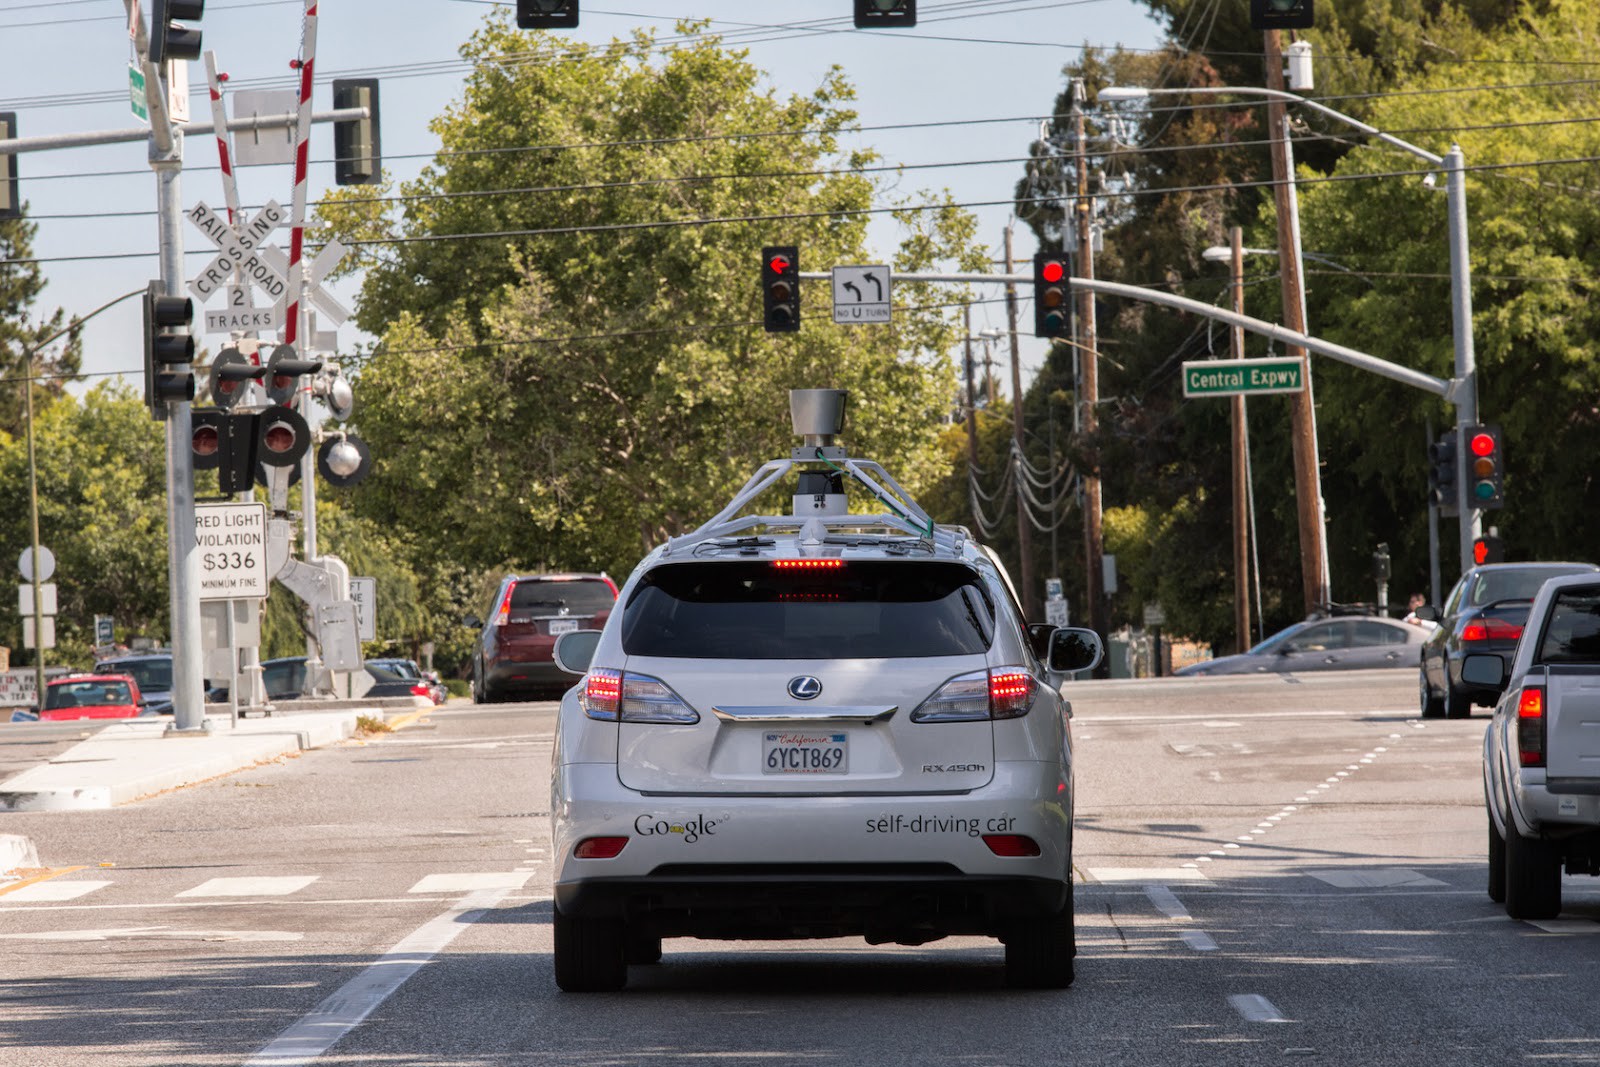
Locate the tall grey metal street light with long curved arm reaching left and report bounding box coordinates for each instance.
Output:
[1099,85,1483,569]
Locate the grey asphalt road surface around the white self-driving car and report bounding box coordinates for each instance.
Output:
[0,670,1600,1067]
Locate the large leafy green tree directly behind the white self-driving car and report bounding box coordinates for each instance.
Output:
[323,16,984,576]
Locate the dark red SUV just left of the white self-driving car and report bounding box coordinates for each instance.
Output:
[466,574,616,704]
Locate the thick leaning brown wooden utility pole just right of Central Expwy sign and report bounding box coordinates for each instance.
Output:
[1266,30,1333,614]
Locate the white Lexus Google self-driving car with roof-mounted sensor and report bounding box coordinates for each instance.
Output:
[550,390,1102,990]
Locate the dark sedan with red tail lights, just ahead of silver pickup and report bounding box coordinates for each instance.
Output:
[1416,563,1600,718]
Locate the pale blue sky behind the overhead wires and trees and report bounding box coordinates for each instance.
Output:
[0,0,1160,399]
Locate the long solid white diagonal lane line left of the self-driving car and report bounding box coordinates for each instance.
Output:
[245,889,510,1067]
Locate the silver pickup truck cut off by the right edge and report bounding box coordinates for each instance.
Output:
[1462,574,1600,918]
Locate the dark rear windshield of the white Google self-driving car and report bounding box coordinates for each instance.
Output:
[622,560,995,659]
